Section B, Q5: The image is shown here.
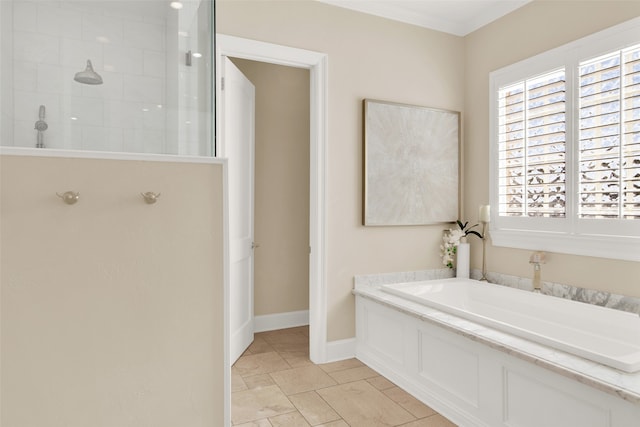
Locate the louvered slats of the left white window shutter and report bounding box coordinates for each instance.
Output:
[498,70,566,217]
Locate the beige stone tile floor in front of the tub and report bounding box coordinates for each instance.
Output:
[231,326,455,427]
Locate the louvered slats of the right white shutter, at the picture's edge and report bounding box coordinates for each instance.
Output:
[578,45,640,219]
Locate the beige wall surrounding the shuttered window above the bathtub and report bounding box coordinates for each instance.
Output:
[464,0,640,296]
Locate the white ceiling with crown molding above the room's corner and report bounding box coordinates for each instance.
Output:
[319,0,531,36]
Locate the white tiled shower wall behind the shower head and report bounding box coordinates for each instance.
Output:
[2,0,172,153]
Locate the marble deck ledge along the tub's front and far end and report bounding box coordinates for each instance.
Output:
[353,270,640,405]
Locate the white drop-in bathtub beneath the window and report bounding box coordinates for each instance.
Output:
[382,278,640,373]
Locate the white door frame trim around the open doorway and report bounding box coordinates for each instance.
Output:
[215,33,329,425]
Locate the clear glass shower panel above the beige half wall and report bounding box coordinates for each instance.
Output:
[0,0,214,156]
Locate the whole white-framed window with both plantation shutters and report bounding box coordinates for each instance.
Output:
[490,19,640,261]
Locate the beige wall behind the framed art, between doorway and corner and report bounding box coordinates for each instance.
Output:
[216,0,464,341]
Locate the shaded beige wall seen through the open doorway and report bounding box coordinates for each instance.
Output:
[232,58,309,316]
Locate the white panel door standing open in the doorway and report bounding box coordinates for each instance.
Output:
[219,57,255,364]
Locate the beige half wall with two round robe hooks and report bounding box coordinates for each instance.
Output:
[0,155,224,427]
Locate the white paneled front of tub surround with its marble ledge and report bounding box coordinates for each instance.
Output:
[354,276,640,427]
